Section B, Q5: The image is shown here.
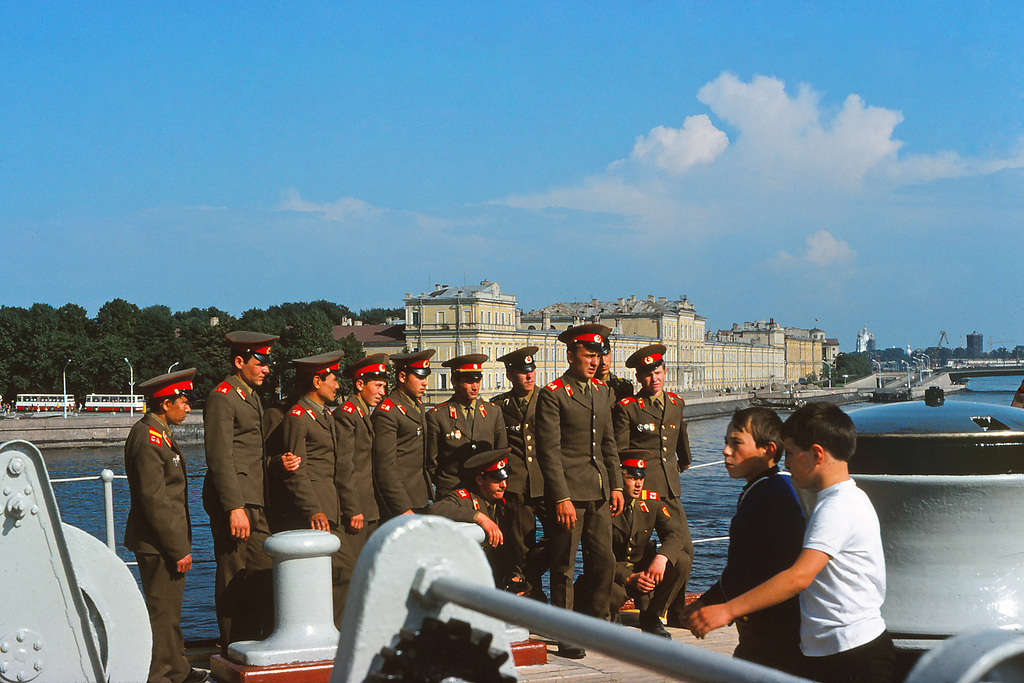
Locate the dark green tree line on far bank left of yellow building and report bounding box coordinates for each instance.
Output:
[0,299,404,402]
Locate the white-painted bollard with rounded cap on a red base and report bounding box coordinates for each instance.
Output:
[227,529,341,667]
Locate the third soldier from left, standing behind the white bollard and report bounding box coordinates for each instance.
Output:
[282,351,362,624]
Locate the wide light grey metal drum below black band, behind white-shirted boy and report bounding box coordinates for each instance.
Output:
[854,474,1024,649]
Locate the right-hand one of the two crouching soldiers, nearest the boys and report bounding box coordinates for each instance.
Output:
[580,451,689,638]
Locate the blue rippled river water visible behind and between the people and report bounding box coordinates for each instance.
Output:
[36,377,1019,640]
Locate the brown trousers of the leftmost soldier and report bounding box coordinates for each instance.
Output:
[135,553,191,683]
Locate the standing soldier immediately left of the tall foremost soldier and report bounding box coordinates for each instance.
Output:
[492,346,551,601]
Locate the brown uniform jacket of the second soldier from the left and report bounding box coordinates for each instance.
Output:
[203,375,266,517]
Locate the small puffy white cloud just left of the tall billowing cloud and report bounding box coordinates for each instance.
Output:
[630,114,729,175]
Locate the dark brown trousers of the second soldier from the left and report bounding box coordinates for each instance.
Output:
[210,506,273,654]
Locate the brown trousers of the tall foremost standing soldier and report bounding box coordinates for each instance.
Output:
[549,501,615,621]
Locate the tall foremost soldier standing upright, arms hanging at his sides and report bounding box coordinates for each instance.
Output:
[537,325,623,658]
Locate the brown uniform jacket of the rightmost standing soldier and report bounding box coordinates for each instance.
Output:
[612,391,690,499]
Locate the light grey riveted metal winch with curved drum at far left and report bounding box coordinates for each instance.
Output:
[0,441,152,681]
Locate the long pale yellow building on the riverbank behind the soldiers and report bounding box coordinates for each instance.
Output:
[404,281,824,403]
